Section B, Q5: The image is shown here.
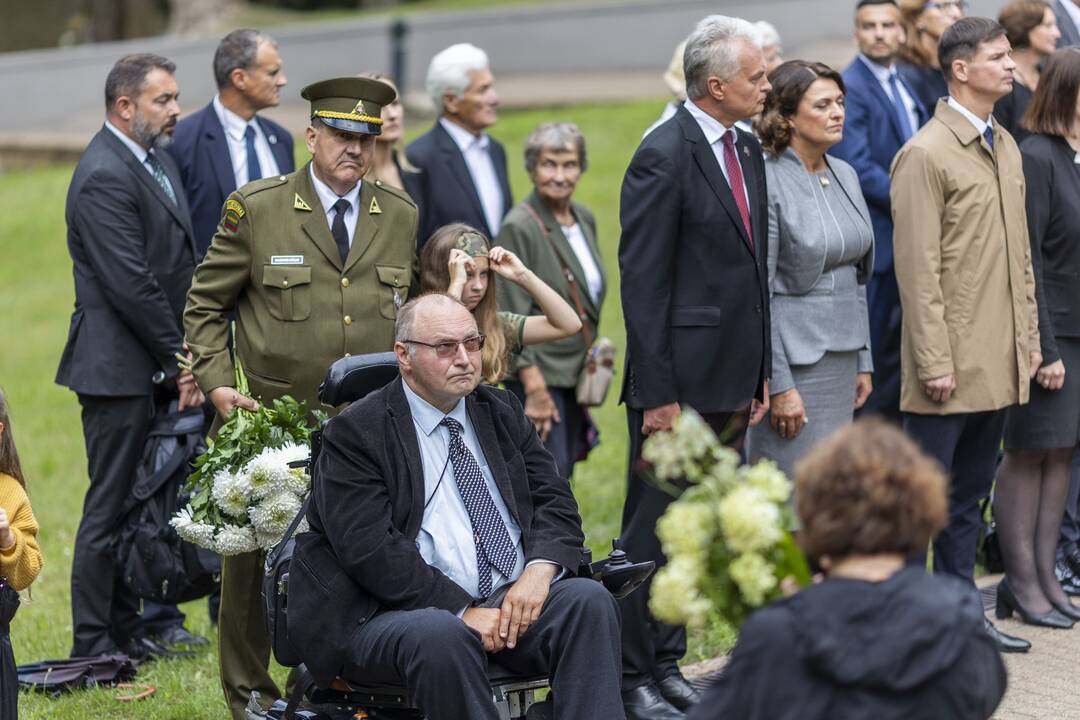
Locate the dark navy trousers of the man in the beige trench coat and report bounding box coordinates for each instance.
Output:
[904,409,1005,581]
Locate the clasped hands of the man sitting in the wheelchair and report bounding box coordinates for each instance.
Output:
[461,562,558,652]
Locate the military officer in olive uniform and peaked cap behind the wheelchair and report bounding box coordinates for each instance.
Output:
[184,77,419,720]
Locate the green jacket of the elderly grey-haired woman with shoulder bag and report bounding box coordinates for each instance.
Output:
[495,190,607,388]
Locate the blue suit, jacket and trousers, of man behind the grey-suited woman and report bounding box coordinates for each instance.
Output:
[829,57,929,421]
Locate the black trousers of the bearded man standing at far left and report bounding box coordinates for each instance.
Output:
[71,395,153,656]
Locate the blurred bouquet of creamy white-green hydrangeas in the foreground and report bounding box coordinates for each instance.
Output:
[642,410,810,628]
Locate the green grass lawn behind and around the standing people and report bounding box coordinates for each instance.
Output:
[0,100,731,720]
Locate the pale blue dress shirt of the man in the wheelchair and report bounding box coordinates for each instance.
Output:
[402,380,525,598]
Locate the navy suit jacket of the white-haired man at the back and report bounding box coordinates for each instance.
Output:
[405,121,513,249]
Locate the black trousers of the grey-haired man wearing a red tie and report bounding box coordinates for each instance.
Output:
[619,408,747,690]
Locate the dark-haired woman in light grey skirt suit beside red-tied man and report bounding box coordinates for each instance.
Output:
[747,60,874,475]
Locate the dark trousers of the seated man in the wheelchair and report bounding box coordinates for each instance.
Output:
[342,578,623,720]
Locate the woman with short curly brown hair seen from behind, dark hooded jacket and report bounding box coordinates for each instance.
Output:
[688,419,1005,720]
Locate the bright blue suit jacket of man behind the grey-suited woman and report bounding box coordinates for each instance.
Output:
[828,57,930,272]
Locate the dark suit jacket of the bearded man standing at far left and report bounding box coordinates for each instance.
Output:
[56,127,195,396]
